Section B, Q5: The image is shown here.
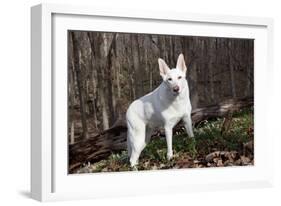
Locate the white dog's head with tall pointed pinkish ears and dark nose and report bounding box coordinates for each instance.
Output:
[158,54,187,95]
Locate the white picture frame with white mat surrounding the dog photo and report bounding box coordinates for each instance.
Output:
[31,4,273,201]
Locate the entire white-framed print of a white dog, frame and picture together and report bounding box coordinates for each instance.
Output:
[31,4,273,201]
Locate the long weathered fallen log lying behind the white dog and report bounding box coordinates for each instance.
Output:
[68,98,253,173]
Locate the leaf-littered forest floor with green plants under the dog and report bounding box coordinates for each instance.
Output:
[76,108,254,173]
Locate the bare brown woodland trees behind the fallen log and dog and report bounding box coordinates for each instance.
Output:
[68,31,254,143]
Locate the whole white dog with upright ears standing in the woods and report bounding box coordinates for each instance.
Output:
[126,54,194,167]
